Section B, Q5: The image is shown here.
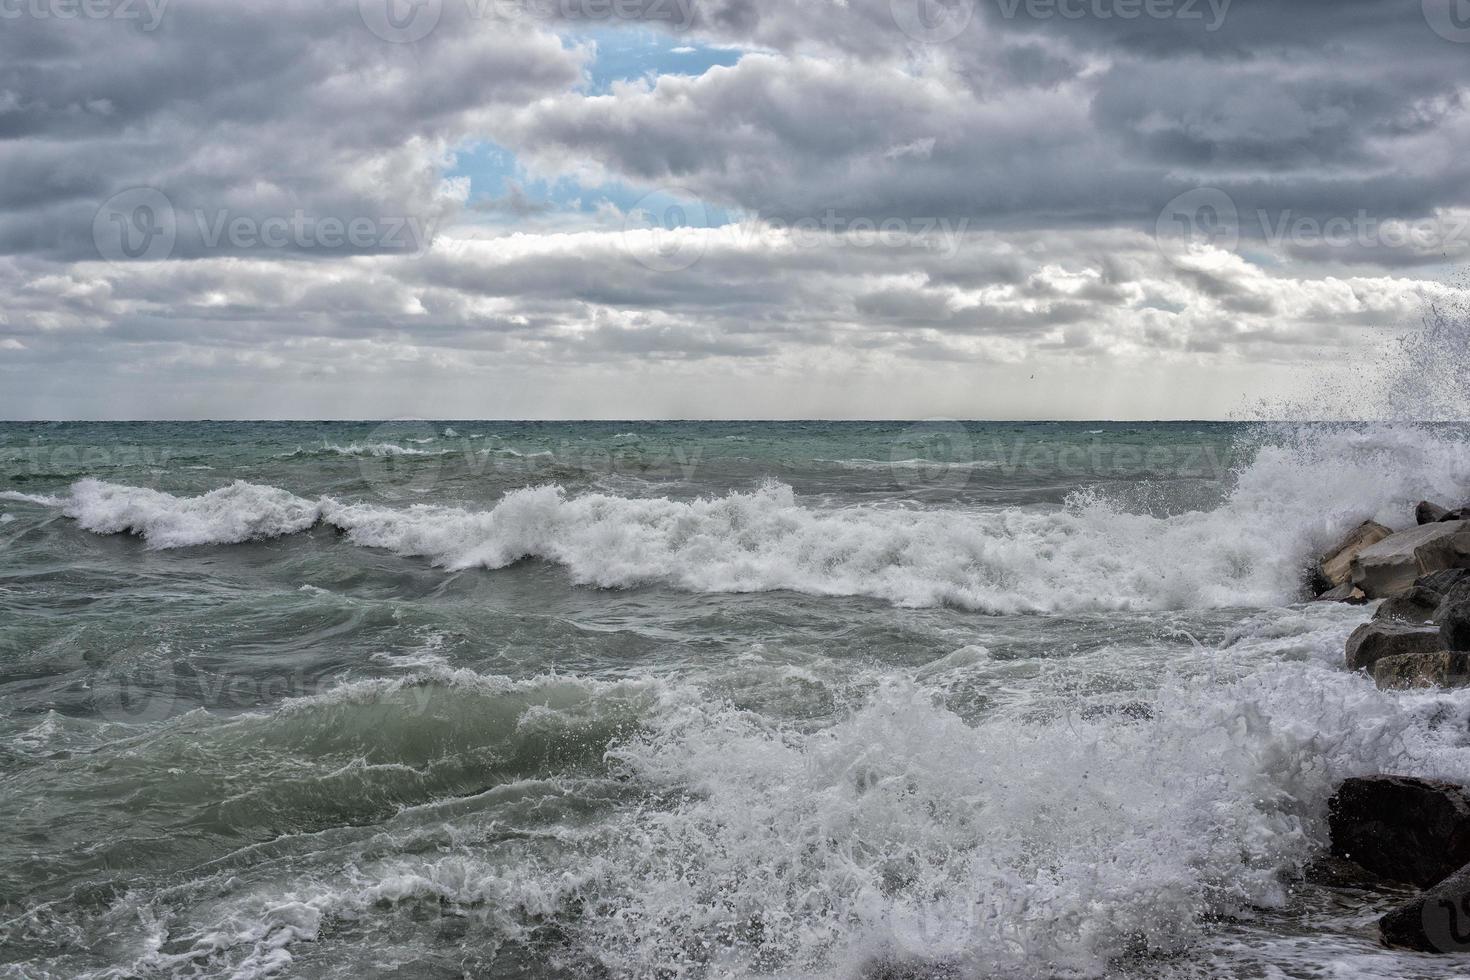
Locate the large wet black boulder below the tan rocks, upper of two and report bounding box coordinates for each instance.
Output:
[1327,776,1470,887]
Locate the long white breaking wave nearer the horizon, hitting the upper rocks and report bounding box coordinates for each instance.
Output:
[20,426,1470,613]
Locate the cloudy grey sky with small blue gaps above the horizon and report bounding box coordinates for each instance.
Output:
[0,0,1470,419]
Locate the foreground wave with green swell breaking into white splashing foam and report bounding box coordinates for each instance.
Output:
[20,643,1470,979]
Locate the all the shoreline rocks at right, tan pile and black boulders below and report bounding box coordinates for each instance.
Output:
[1310,501,1470,954]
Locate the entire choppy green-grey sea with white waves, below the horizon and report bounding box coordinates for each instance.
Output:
[0,422,1470,979]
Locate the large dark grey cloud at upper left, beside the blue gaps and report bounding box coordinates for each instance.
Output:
[0,0,582,260]
